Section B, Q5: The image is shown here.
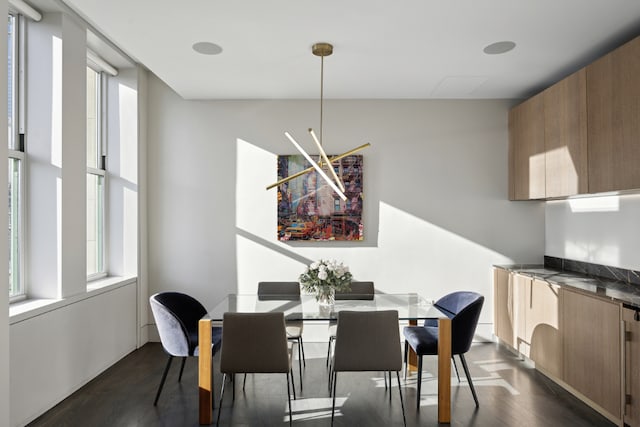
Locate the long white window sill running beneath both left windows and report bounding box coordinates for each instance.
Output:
[9,276,137,325]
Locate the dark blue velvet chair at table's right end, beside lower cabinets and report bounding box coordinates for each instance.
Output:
[403,291,484,410]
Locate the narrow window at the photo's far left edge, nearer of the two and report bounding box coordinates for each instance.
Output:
[7,13,26,300]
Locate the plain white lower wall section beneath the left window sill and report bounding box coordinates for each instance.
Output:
[9,281,137,426]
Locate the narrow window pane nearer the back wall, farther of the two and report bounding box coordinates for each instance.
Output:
[87,67,106,280]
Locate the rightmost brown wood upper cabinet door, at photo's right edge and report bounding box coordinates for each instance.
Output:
[587,38,640,193]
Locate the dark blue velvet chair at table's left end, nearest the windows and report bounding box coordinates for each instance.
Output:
[149,292,222,406]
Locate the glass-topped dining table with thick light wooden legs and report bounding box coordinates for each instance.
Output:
[198,293,451,425]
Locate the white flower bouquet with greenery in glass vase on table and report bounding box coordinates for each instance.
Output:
[299,259,352,304]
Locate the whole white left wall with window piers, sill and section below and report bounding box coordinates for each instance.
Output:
[5,8,142,426]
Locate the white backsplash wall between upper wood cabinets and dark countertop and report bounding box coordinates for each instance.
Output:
[545,195,640,270]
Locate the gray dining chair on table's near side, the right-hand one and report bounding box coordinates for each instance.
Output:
[330,310,407,426]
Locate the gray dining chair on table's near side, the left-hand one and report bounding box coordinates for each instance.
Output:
[217,312,296,425]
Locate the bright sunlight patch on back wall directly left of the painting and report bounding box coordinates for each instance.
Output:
[234,138,278,242]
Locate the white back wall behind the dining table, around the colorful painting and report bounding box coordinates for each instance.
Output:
[148,76,544,340]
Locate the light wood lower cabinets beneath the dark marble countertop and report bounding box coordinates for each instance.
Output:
[494,268,624,427]
